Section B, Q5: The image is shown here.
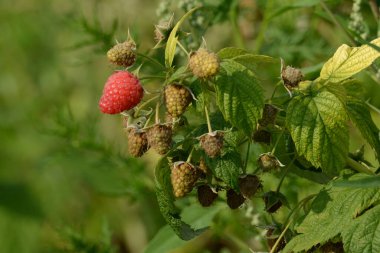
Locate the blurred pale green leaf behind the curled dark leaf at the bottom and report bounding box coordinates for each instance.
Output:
[144,204,225,253]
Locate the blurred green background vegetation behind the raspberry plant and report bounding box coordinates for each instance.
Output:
[0,0,380,253]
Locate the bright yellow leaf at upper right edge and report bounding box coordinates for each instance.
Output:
[320,38,380,83]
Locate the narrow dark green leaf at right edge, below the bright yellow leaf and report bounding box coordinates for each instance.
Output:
[346,97,380,160]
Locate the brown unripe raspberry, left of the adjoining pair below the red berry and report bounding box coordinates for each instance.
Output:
[128,128,148,157]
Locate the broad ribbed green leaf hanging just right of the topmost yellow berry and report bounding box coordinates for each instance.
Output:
[215,60,264,136]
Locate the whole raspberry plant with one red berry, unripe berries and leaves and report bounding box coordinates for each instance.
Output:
[100,5,380,252]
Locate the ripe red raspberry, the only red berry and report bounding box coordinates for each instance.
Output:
[99,71,144,114]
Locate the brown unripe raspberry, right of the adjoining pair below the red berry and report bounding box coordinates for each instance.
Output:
[147,124,172,155]
